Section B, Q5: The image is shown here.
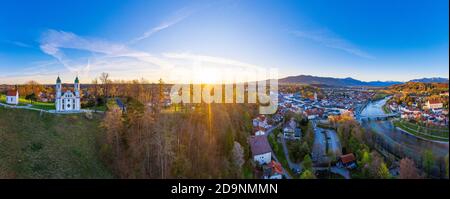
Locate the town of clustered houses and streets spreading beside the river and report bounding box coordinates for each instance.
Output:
[250,85,448,179]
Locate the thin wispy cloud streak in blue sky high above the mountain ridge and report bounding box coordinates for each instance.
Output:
[292,29,375,59]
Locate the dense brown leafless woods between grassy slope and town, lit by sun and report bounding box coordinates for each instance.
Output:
[101,98,257,178]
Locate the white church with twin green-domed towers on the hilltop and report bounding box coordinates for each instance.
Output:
[55,76,81,112]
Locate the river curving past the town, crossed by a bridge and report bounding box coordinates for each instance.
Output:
[361,97,449,160]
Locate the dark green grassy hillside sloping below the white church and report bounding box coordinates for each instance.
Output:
[0,107,112,178]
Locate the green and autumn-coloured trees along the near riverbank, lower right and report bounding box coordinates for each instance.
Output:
[333,118,448,179]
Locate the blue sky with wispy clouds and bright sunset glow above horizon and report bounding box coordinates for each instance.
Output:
[0,0,449,84]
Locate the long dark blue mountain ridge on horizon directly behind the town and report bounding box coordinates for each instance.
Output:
[279,75,403,87]
